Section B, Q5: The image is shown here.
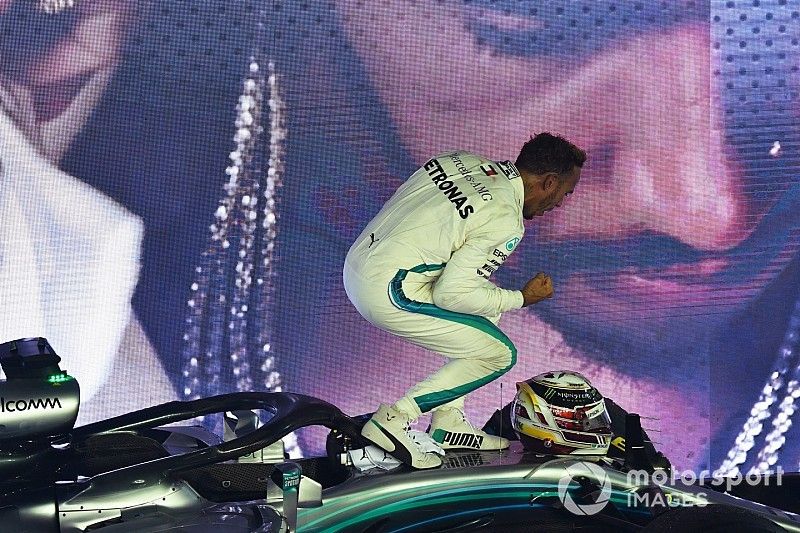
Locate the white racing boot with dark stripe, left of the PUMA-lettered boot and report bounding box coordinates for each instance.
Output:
[361,404,442,469]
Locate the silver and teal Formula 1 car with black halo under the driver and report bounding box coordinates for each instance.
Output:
[0,338,800,533]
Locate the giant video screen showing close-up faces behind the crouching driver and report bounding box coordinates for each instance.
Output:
[0,0,800,472]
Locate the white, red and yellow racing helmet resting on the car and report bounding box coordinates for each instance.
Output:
[511,370,611,455]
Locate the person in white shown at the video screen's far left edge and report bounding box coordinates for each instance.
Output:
[0,0,139,402]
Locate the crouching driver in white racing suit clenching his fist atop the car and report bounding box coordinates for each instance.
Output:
[344,133,586,468]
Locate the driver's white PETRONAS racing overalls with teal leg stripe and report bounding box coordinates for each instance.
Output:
[344,152,524,418]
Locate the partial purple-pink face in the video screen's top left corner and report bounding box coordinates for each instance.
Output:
[0,0,136,145]
